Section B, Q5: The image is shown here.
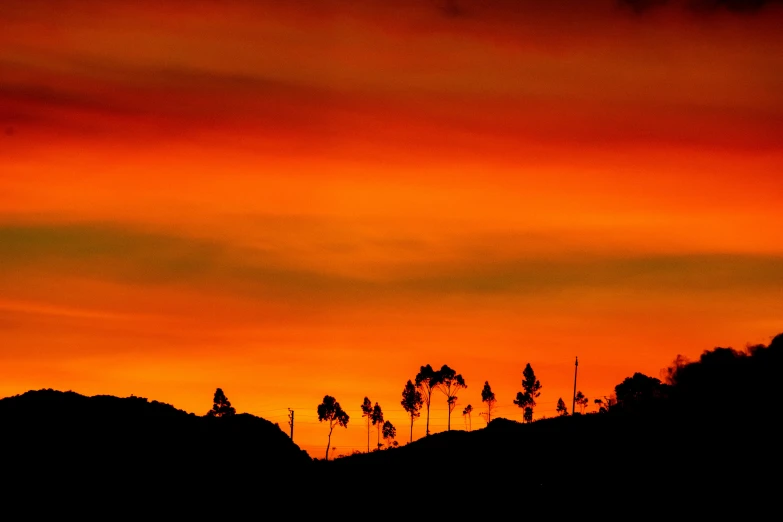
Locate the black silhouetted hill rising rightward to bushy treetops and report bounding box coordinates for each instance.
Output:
[314,336,783,506]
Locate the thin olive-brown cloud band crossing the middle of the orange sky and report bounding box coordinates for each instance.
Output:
[0,221,783,305]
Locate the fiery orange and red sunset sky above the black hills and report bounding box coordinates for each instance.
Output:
[0,0,783,457]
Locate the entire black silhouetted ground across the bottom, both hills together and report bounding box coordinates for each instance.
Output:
[0,336,783,508]
